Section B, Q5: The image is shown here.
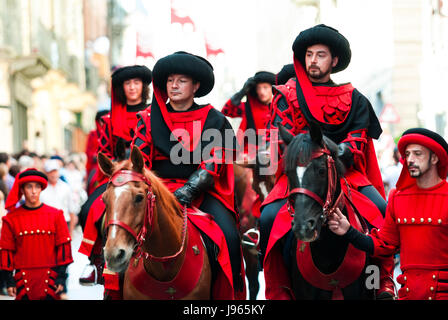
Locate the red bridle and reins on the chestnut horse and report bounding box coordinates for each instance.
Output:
[106,170,187,262]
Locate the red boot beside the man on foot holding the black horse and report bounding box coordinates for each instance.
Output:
[372,256,397,300]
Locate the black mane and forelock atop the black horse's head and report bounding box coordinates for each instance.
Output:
[285,133,345,174]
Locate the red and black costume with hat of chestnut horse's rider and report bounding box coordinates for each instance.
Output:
[132,52,244,298]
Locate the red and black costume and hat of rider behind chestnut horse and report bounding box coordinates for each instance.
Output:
[79,65,152,283]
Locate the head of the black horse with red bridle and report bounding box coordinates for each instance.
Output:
[279,124,345,241]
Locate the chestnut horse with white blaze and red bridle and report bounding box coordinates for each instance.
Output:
[98,147,212,300]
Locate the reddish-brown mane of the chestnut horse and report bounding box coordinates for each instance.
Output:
[114,160,182,216]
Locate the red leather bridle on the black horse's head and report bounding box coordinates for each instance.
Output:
[287,147,343,223]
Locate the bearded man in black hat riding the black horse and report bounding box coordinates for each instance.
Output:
[258,24,393,300]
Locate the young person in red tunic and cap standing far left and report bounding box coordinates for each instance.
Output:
[0,169,73,300]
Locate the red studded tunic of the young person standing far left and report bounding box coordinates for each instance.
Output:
[0,204,73,300]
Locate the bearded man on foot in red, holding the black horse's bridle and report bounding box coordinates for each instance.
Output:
[329,128,448,300]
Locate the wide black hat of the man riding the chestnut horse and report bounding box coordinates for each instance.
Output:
[153,51,215,97]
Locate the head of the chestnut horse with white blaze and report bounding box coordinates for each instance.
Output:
[98,147,153,272]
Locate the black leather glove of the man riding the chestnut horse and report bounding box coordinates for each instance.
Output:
[174,169,214,206]
